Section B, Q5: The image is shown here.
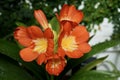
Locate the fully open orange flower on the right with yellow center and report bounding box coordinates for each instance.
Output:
[59,26,91,58]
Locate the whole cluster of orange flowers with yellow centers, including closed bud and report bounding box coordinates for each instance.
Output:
[14,4,91,76]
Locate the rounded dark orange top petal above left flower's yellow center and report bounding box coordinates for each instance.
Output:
[27,26,43,39]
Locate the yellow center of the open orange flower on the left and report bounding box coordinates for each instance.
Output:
[33,38,48,54]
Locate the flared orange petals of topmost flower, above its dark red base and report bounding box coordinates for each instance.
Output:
[56,4,83,24]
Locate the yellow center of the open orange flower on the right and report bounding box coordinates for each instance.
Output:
[61,35,78,52]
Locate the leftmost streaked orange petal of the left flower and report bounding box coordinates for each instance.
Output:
[14,27,32,47]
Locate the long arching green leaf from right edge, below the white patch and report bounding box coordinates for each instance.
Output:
[58,40,120,78]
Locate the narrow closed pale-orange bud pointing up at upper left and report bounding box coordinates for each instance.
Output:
[34,10,48,29]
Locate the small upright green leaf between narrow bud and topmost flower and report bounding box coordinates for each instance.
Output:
[50,17,60,34]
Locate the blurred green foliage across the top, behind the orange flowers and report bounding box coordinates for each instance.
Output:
[0,0,120,39]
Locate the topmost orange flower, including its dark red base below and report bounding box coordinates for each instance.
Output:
[56,4,83,40]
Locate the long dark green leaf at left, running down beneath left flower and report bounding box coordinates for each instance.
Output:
[0,39,46,79]
